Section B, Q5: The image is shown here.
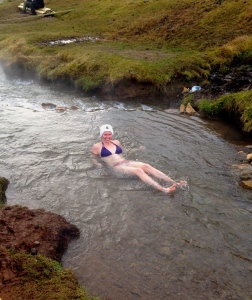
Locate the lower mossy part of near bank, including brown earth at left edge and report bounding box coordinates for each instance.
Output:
[0,246,98,300]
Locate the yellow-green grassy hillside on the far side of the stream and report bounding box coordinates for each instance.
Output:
[0,0,252,130]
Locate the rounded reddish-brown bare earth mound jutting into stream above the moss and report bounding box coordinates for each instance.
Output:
[0,206,79,261]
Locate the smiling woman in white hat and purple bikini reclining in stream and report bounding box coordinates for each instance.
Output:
[92,124,186,194]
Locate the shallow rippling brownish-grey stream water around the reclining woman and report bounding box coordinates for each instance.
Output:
[0,64,252,300]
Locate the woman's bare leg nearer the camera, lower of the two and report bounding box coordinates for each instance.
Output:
[114,166,176,193]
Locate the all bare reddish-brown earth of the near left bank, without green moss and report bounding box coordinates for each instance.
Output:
[0,177,80,299]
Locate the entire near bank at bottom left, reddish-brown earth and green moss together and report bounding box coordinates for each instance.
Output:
[0,177,95,299]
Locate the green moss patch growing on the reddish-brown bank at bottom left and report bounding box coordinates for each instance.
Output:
[9,250,98,300]
